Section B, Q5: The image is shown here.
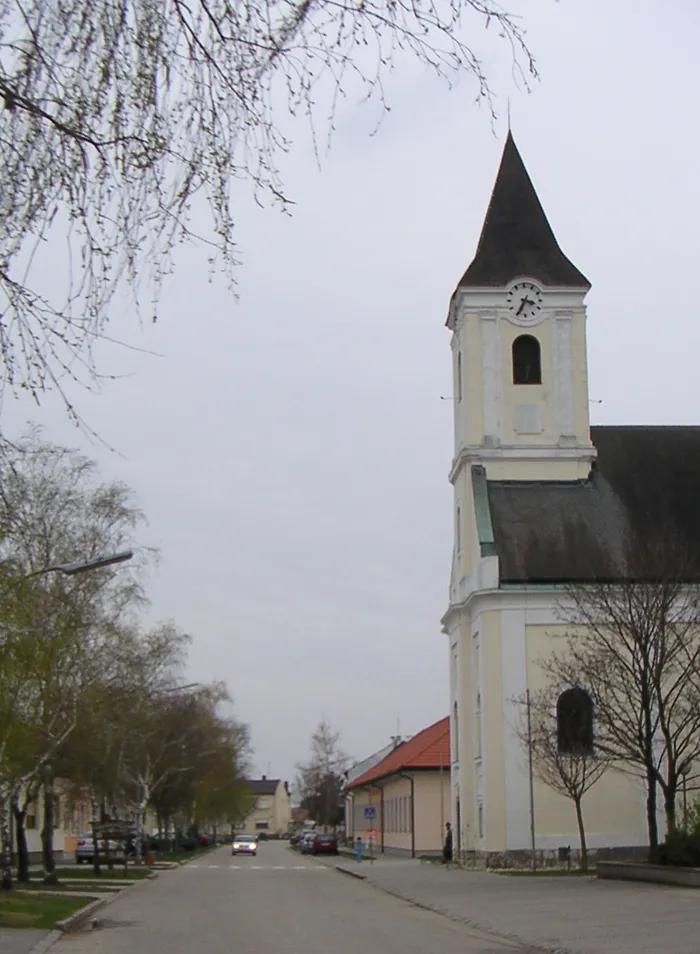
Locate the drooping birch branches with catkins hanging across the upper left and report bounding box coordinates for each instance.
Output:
[0,0,536,407]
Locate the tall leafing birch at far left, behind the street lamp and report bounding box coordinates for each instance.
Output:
[0,429,148,882]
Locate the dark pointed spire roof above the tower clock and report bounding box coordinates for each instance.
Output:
[458,131,590,288]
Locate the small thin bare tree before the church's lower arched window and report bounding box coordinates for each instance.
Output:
[516,686,610,871]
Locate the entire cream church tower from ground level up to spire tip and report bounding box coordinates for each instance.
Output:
[442,132,596,850]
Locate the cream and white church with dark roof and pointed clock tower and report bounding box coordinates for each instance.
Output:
[442,132,700,861]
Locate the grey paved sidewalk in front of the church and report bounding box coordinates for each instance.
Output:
[326,857,700,954]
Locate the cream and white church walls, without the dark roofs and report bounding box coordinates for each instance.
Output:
[443,136,652,856]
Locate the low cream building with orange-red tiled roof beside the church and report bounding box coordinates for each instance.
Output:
[345,718,450,857]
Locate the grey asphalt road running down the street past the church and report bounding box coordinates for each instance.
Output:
[52,842,536,954]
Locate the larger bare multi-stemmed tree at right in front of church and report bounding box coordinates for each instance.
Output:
[543,532,700,854]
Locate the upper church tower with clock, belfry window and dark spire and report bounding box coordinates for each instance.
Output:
[447,132,595,483]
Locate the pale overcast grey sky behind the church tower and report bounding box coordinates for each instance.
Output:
[2,0,700,780]
